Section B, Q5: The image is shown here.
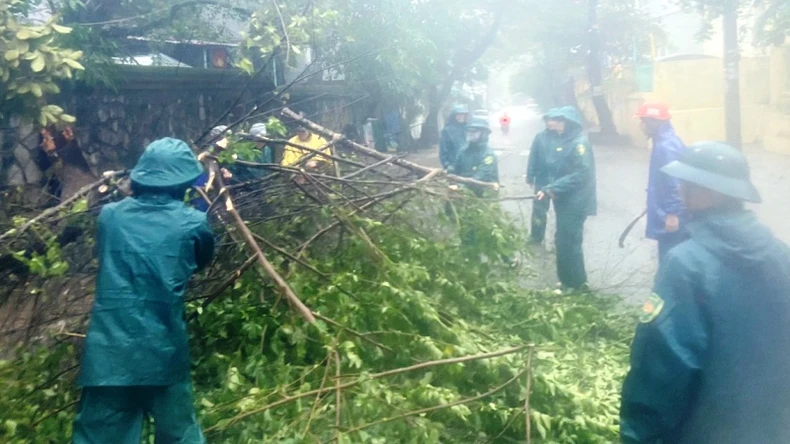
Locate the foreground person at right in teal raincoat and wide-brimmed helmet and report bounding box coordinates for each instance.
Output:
[620,142,790,444]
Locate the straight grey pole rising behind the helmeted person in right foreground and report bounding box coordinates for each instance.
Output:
[722,4,743,149]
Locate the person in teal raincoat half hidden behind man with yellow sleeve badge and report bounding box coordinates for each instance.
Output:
[527,109,558,244]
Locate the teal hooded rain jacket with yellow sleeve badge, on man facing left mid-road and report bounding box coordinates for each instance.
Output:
[543,106,597,216]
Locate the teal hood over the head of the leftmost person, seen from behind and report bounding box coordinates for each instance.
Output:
[131,137,203,188]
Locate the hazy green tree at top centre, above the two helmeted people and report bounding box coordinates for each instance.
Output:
[312,0,504,146]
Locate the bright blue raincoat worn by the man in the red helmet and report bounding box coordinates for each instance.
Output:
[645,122,687,240]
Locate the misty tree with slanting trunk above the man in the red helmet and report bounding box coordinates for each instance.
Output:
[506,0,660,125]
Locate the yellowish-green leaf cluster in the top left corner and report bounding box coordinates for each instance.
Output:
[0,0,83,125]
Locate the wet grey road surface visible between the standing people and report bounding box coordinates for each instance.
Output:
[412,107,790,302]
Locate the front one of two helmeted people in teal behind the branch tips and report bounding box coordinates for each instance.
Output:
[448,117,499,197]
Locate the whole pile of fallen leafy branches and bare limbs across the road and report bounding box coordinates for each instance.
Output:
[0,109,628,443]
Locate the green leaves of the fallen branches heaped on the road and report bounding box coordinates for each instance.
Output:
[0,192,635,444]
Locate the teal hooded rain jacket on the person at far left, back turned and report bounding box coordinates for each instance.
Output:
[78,139,214,387]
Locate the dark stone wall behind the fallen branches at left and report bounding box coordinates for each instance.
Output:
[0,67,364,185]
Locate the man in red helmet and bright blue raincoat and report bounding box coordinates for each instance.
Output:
[636,103,688,261]
